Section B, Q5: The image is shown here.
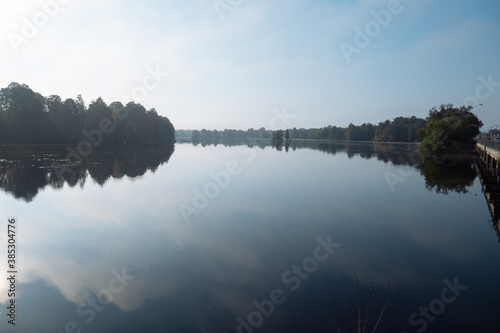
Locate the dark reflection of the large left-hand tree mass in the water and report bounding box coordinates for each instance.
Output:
[0,144,174,202]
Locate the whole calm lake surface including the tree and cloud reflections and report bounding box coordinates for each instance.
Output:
[0,143,500,333]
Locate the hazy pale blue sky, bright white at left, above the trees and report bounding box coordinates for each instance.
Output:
[0,0,500,129]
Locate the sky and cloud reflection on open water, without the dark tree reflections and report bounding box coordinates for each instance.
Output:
[0,143,499,333]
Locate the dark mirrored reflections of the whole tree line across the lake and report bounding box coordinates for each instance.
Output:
[0,140,476,202]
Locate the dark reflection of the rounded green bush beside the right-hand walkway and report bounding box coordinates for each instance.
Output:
[419,158,477,194]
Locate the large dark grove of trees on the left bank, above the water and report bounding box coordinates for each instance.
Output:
[0,82,175,144]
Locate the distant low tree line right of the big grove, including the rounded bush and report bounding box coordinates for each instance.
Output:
[176,104,483,159]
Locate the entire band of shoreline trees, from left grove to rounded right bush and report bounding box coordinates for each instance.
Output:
[0,82,483,159]
